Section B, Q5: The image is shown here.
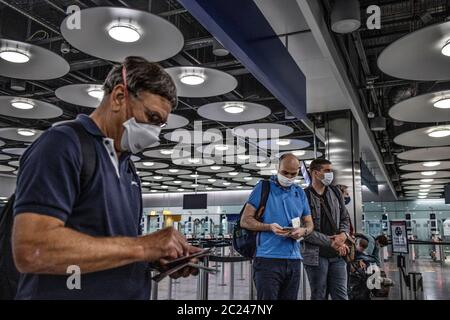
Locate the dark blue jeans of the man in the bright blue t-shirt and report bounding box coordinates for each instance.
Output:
[253,258,300,300]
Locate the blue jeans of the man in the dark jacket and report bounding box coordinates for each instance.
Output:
[305,257,348,300]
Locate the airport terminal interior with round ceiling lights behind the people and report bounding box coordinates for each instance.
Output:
[0,0,450,300]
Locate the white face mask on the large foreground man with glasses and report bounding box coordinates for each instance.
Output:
[120,118,161,154]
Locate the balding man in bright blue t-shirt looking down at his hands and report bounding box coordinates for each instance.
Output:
[241,153,313,300]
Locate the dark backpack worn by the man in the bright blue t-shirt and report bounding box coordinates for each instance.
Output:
[233,180,270,258]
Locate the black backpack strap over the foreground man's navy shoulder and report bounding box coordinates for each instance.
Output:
[61,121,97,190]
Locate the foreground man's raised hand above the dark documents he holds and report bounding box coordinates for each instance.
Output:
[137,227,188,262]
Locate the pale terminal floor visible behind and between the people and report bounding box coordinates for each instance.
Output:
[154,259,450,300]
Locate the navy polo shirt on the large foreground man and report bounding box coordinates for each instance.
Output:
[14,115,150,299]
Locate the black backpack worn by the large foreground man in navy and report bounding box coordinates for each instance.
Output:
[0,121,96,300]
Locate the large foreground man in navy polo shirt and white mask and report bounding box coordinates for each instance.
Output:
[12,57,199,299]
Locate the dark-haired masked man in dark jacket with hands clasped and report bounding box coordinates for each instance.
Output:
[302,159,350,300]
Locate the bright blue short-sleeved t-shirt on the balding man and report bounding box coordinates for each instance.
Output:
[248,176,311,259]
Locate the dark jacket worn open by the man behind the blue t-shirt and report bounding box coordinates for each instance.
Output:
[302,186,350,266]
